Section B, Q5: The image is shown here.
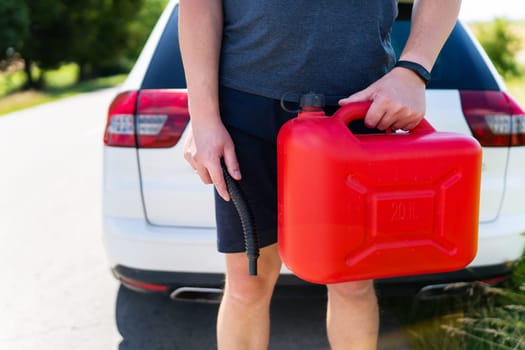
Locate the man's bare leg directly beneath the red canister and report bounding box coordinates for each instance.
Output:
[326,281,379,350]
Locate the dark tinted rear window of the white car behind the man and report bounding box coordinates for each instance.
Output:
[142,4,499,90]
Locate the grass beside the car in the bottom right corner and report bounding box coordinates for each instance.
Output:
[398,283,525,350]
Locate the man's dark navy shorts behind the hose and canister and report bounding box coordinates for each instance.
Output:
[215,87,376,253]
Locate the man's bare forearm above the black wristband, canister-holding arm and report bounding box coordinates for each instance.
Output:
[400,0,461,71]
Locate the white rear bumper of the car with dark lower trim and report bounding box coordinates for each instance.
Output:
[104,217,525,287]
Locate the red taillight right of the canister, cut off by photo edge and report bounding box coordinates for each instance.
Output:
[460,91,525,147]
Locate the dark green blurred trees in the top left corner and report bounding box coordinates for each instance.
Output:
[0,0,168,88]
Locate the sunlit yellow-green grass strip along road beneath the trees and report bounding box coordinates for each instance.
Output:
[0,64,126,116]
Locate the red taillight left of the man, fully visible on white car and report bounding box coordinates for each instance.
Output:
[104,90,190,148]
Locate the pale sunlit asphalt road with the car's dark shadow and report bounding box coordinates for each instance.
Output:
[0,89,408,350]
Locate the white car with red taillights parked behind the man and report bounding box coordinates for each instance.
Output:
[103,1,525,296]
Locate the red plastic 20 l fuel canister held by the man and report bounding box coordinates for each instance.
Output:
[277,97,481,284]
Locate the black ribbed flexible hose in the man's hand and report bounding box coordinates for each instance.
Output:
[222,164,259,276]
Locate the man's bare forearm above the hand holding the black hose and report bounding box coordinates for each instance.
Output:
[179,0,223,123]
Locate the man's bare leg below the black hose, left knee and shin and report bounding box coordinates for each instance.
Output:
[217,244,281,350]
